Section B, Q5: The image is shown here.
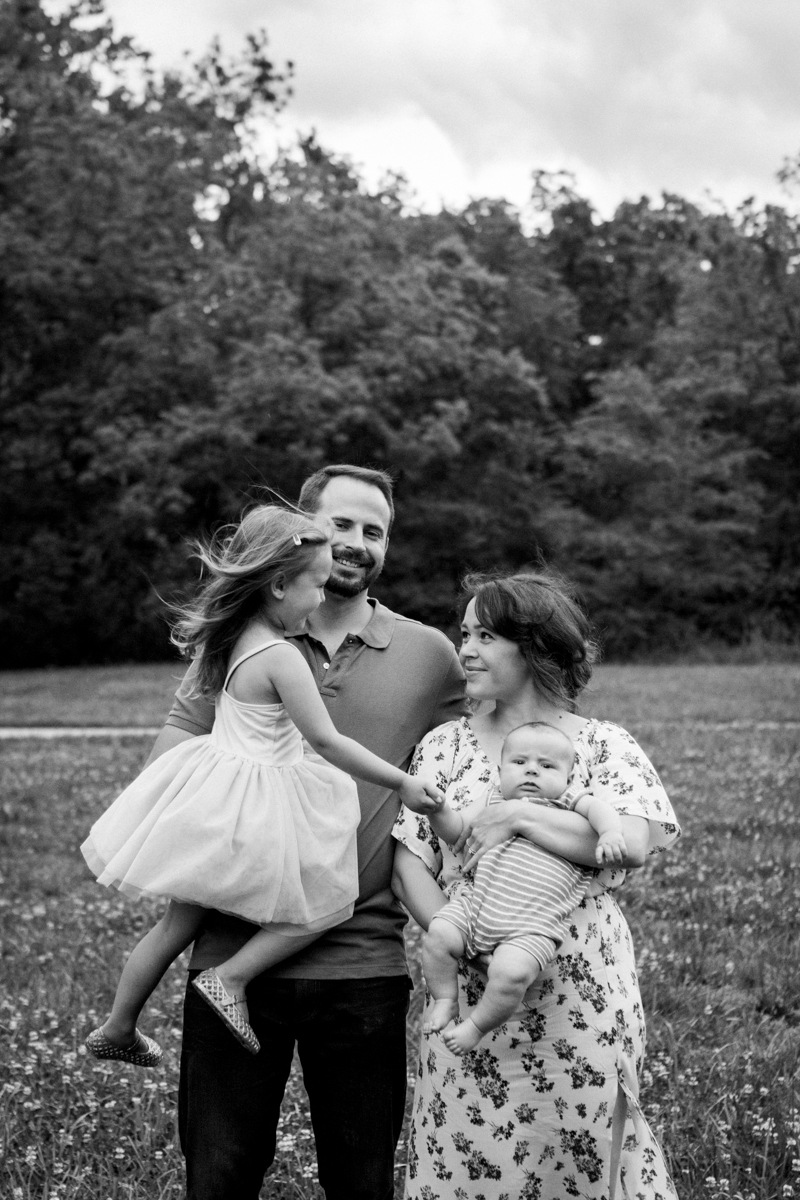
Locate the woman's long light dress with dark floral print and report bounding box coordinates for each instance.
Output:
[393,719,679,1200]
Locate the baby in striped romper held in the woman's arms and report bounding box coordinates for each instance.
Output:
[422,721,626,1055]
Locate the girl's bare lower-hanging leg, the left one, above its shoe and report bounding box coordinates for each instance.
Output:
[102,900,205,1046]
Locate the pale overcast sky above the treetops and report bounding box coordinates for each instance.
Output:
[97,0,800,214]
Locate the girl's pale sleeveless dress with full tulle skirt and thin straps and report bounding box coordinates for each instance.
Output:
[80,640,360,935]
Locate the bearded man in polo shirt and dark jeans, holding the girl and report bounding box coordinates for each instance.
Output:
[151,464,464,1200]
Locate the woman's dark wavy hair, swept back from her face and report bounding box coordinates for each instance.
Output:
[459,571,599,712]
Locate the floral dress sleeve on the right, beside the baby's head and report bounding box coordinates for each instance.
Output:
[584,721,680,854]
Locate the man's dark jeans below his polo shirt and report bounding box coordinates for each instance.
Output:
[179,972,409,1200]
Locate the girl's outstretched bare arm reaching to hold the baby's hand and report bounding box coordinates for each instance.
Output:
[264,644,441,814]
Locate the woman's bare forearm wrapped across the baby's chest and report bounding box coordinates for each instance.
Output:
[453,800,650,870]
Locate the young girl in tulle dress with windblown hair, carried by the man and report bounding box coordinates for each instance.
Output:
[80,505,440,1067]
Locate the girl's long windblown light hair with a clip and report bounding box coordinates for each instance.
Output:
[172,504,331,698]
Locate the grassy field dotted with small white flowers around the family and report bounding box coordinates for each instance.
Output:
[0,665,800,1200]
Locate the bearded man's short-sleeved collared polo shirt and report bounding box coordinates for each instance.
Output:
[167,600,465,979]
